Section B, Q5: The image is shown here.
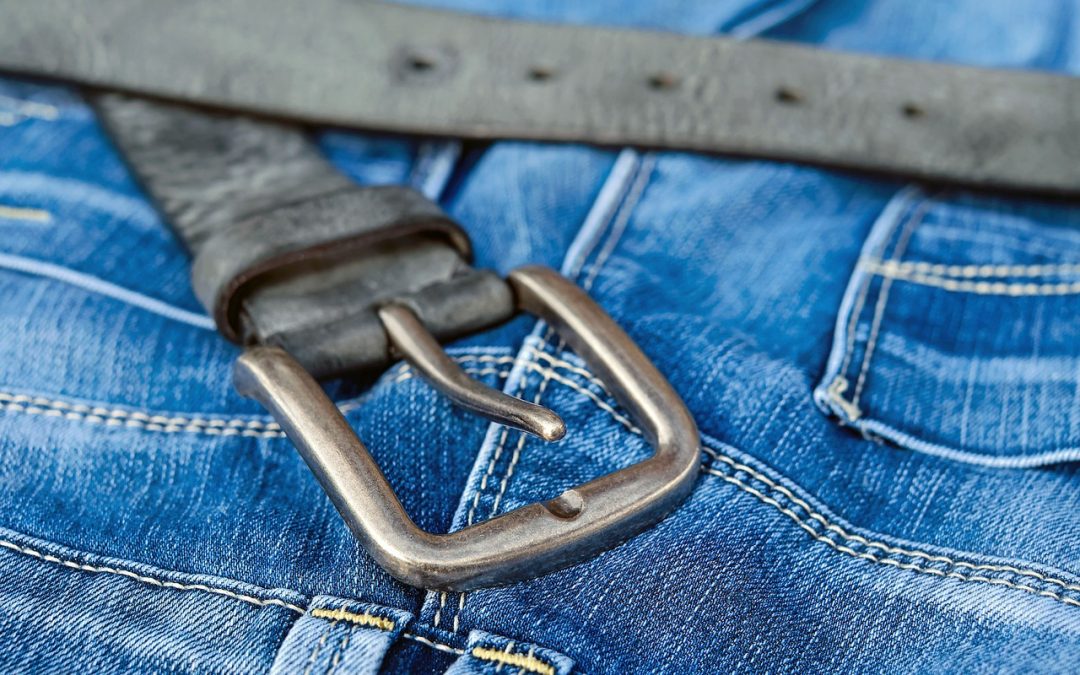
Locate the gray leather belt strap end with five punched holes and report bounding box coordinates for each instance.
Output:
[0,0,1080,194]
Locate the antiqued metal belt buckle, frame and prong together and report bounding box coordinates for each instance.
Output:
[234,267,700,591]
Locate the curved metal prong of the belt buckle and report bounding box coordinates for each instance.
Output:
[379,303,566,441]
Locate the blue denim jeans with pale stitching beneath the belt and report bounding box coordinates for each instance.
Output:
[0,0,1080,674]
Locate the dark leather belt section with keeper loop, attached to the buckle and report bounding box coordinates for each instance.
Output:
[94,94,514,377]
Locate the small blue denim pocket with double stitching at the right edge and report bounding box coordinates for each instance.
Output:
[814,189,1080,468]
